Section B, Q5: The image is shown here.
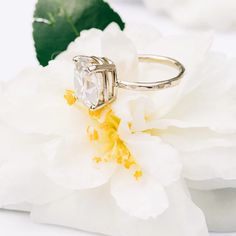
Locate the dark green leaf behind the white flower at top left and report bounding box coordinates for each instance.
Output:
[33,0,124,66]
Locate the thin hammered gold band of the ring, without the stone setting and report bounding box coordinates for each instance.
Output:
[117,55,185,91]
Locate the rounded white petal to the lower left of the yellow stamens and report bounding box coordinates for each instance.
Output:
[45,136,116,189]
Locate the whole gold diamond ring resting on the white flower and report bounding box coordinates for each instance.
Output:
[73,55,185,110]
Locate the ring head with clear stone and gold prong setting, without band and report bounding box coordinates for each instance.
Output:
[74,56,116,110]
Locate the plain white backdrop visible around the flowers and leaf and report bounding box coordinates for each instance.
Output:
[0,0,236,236]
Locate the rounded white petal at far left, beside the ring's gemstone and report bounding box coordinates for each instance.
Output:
[0,62,92,135]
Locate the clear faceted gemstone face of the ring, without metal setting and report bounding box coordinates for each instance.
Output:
[74,59,102,108]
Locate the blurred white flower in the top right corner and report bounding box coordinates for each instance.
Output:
[144,0,236,29]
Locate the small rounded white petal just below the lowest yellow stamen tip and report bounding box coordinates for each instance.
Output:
[111,170,168,219]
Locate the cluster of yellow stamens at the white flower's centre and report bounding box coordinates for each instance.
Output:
[64,91,143,180]
